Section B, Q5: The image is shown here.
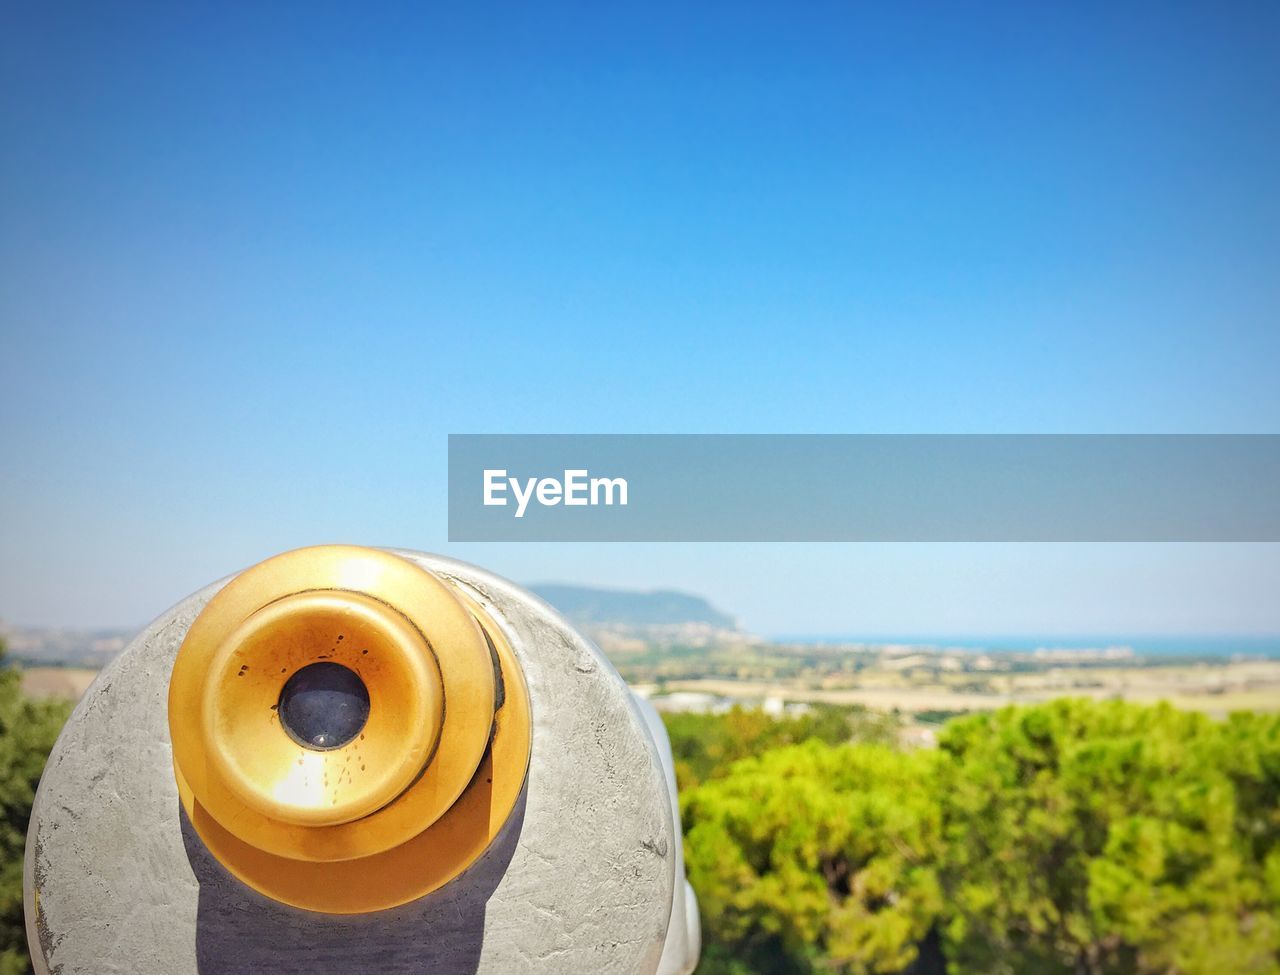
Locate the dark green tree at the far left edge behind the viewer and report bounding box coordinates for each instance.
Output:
[0,644,70,975]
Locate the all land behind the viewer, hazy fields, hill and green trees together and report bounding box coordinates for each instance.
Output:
[10,585,1280,975]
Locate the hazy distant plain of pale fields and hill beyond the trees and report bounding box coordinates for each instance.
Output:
[12,585,1280,722]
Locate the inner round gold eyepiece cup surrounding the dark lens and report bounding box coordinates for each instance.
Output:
[201,590,444,827]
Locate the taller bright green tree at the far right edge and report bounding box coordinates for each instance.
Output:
[938,700,1280,975]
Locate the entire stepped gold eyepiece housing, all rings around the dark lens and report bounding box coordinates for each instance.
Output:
[169,545,531,914]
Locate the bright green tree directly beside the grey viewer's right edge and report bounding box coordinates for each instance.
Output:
[684,741,941,975]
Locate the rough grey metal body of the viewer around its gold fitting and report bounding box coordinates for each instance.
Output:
[26,551,699,975]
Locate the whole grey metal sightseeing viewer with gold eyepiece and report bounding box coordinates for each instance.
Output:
[26,546,699,975]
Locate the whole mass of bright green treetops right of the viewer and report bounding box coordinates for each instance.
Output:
[673,699,1280,975]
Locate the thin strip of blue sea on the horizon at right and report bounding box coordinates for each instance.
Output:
[771,633,1280,659]
